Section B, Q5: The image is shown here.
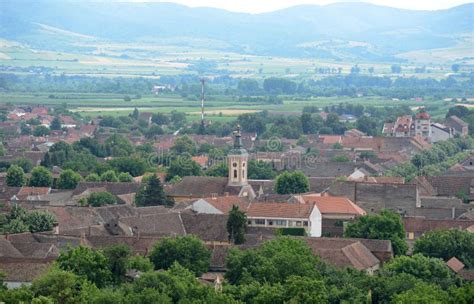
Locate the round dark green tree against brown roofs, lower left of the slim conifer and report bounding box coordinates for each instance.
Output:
[150,235,211,276]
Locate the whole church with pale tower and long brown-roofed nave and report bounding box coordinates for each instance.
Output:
[167,126,262,202]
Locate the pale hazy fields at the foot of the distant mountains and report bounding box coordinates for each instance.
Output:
[0,40,462,79]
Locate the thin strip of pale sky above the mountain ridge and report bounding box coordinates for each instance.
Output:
[127,0,473,13]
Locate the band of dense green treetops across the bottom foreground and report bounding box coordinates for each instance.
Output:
[0,237,474,304]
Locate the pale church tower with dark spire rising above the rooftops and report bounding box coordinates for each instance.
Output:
[227,126,249,187]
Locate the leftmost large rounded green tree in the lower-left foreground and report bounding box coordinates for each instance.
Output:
[56,246,112,288]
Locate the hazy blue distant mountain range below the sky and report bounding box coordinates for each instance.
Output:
[0,0,474,60]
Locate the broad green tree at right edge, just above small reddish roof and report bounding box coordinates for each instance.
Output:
[413,229,474,268]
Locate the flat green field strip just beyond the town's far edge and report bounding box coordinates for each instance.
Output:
[0,93,450,121]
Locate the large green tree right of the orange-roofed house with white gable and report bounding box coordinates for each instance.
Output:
[344,209,408,255]
